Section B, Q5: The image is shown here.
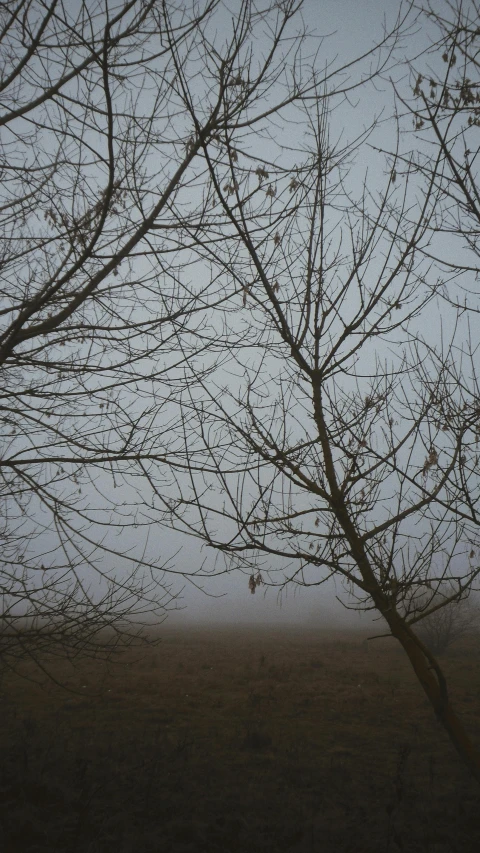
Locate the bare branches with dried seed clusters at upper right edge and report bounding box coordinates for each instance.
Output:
[388,0,480,313]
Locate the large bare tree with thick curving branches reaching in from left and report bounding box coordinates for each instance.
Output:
[0,0,332,660]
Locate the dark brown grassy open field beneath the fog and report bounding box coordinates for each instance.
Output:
[0,628,480,853]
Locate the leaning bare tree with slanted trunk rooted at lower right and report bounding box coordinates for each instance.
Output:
[159,31,480,781]
